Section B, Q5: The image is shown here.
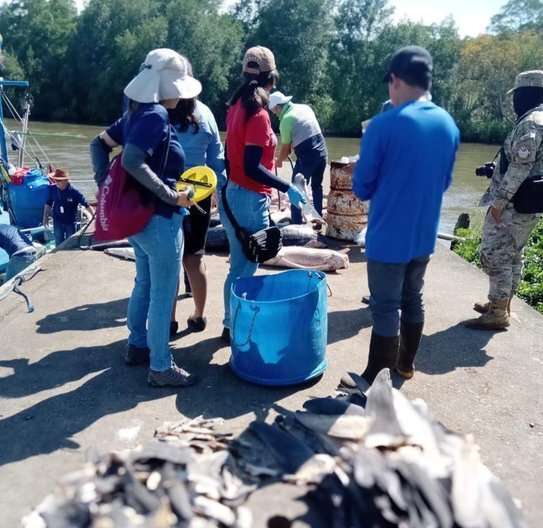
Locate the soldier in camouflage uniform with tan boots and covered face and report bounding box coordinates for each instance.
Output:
[464,70,543,330]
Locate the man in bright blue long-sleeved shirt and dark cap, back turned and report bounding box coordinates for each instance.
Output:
[353,46,460,383]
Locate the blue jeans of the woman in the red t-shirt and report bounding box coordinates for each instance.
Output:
[221,182,270,328]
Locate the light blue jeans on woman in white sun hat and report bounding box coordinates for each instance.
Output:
[127,213,184,371]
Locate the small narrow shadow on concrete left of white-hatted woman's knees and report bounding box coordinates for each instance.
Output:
[36,299,128,334]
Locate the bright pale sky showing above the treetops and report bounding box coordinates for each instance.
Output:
[72,0,506,37]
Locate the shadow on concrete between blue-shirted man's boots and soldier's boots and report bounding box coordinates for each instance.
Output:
[416,323,496,374]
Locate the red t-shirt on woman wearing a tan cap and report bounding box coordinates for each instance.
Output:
[226,100,277,194]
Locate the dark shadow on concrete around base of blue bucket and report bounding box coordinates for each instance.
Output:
[174,337,321,420]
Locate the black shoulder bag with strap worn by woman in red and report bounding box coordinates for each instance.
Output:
[221,184,283,264]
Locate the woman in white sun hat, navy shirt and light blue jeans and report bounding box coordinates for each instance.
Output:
[91,49,202,386]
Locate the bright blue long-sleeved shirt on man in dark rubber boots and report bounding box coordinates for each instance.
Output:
[353,101,460,263]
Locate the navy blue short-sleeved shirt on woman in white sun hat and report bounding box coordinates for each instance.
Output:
[106,103,185,217]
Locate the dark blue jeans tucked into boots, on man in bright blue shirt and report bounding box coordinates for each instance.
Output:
[368,256,430,337]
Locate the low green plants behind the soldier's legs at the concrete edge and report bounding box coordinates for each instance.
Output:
[453,219,543,313]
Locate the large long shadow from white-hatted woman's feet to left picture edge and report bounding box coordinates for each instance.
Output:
[0,340,191,465]
